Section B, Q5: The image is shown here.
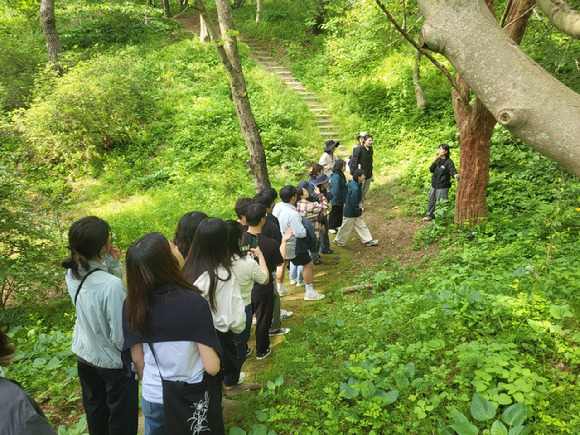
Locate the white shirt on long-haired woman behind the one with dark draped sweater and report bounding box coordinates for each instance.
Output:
[193,266,246,334]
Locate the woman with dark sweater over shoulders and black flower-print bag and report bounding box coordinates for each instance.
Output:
[123,233,224,435]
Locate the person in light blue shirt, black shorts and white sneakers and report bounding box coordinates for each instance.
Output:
[272,185,325,301]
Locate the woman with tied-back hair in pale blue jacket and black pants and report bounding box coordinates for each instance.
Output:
[62,216,139,435]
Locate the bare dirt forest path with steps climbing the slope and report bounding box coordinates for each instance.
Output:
[173,15,438,430]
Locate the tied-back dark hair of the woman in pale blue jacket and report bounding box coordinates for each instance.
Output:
[61,216,111,279]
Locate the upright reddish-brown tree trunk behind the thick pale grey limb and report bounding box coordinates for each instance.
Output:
[453,0,533,224]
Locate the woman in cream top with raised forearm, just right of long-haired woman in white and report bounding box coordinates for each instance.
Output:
[224,220,270,389]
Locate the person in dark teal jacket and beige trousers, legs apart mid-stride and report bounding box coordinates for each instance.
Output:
[332,169,379,247]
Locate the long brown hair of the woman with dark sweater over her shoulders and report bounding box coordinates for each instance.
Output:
[126,233,201,335]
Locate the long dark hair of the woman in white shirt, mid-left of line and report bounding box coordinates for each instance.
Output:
[182,217,232,313]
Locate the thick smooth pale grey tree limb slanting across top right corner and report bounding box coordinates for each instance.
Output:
[419,0,580,176]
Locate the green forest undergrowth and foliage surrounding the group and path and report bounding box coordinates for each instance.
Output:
[0,0,580,435]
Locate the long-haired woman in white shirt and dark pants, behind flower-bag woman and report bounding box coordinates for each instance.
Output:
[183,217,246,386]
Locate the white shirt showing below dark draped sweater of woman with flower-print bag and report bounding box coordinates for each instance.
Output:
[143,341,205,404]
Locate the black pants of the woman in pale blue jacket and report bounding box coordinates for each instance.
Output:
[77,361,139,435]
